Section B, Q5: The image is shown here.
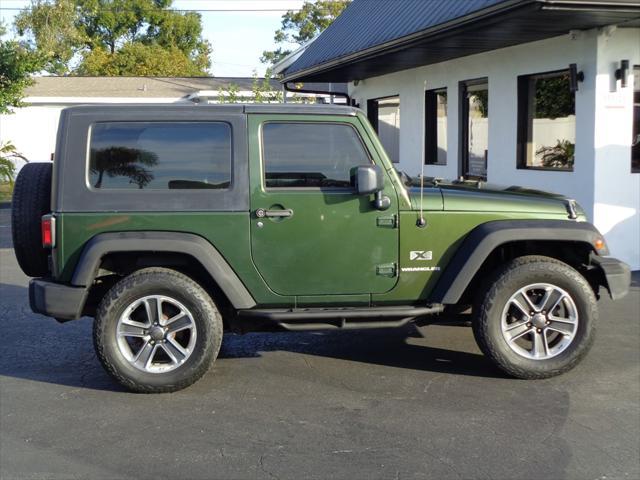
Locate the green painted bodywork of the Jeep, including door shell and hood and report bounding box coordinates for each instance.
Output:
[55,107,584,307]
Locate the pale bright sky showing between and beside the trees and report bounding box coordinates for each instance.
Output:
[0,0,304,77]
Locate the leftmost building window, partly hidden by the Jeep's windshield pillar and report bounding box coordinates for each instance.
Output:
[367,95,400,163]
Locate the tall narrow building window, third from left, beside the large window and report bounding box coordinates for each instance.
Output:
[460,78,489,180]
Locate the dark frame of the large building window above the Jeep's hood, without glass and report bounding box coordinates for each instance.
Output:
[516,68,577,173]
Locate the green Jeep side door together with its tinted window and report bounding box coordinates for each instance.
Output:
[249,115,399,296]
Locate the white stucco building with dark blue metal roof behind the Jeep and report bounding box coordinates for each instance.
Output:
[284,0,640,270]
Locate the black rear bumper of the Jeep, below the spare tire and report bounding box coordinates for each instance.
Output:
[29,278,87,320]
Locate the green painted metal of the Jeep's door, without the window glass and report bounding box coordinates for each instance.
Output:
[249,115,399,296]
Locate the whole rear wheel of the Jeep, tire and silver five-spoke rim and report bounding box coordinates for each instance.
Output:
[94,268,222,393]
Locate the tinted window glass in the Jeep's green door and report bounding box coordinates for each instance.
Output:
[262,123,371,188]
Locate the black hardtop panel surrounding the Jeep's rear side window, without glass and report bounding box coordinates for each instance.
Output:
[58,109,250,213]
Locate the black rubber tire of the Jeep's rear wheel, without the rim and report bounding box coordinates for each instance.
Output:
[93,268,222,393]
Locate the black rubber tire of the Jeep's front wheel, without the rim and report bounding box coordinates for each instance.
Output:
[473,256,598,379]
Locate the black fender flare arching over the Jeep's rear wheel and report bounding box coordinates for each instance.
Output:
[71,231,256,309]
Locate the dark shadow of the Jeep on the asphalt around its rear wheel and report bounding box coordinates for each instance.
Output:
[0,284,501,391]
